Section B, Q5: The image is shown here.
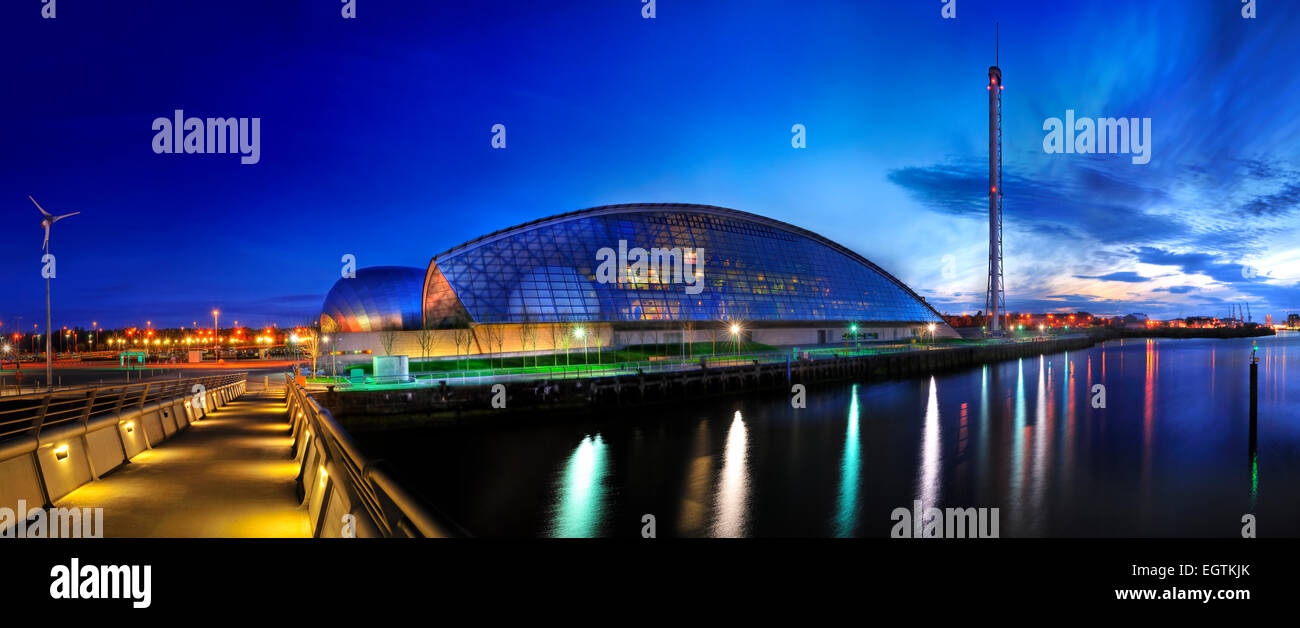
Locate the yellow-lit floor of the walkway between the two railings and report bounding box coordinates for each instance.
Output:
[55,390,311,538]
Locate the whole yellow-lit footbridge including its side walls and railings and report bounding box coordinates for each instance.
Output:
[0,373,465,538]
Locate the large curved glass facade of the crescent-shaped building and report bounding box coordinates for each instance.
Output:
[424,204,943,326]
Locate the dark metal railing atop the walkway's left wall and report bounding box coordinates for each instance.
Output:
[0,373,247,441]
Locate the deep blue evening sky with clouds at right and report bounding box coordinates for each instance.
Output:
[0,0,1300,332]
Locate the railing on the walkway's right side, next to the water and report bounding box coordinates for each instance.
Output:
[285,374,468,538]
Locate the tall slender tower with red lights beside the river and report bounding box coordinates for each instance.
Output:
[984,26,1006,335]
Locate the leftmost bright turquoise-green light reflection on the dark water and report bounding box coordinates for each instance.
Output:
[551,434,606,538]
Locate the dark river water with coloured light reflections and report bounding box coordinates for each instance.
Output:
[387,334,1300,537]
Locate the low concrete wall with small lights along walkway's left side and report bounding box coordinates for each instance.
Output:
[0,381,246,535]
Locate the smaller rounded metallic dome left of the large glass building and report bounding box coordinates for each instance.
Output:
[321,267,424,333]
